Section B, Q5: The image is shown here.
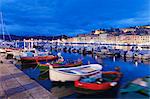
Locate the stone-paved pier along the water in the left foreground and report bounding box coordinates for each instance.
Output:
[0,55,57,99]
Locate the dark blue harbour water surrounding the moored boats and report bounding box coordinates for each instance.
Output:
[16,51,150,99]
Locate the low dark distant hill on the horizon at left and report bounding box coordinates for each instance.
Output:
[0,35,68,40]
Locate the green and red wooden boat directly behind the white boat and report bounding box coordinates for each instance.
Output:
[38,61,82,72]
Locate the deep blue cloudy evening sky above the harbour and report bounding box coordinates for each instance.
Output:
[0,0,150,36]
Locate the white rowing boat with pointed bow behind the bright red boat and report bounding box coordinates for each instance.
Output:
[49,64,102,82]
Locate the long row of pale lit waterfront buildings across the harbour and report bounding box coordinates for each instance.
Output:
[67,33,150,45]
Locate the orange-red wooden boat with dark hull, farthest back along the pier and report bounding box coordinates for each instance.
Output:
[21,55,58,64]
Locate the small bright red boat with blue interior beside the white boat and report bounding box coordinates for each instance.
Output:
[74,71,121,91]
